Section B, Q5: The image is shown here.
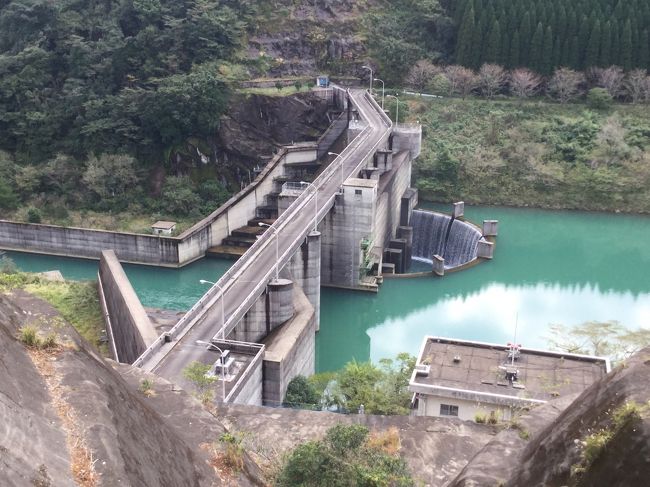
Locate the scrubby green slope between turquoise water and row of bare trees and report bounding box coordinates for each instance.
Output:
[409,98,650,213]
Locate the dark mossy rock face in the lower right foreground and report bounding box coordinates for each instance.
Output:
[451,348,650,487]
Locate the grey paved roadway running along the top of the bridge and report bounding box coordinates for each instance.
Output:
[147,90,391,385]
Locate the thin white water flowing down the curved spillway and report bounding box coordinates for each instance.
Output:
[411,210,481,269]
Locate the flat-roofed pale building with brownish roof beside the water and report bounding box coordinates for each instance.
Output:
[409,336,610,420]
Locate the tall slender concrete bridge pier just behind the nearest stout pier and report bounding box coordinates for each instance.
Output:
[285,231,321,330]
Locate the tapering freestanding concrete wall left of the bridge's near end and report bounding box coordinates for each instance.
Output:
[98,250,158,364]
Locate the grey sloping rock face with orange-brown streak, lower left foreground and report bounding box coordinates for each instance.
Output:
[0,291,257,486]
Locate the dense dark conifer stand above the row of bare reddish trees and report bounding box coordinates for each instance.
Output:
[450,0,650,75]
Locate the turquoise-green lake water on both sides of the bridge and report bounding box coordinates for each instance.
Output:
[8,206,650,372]
